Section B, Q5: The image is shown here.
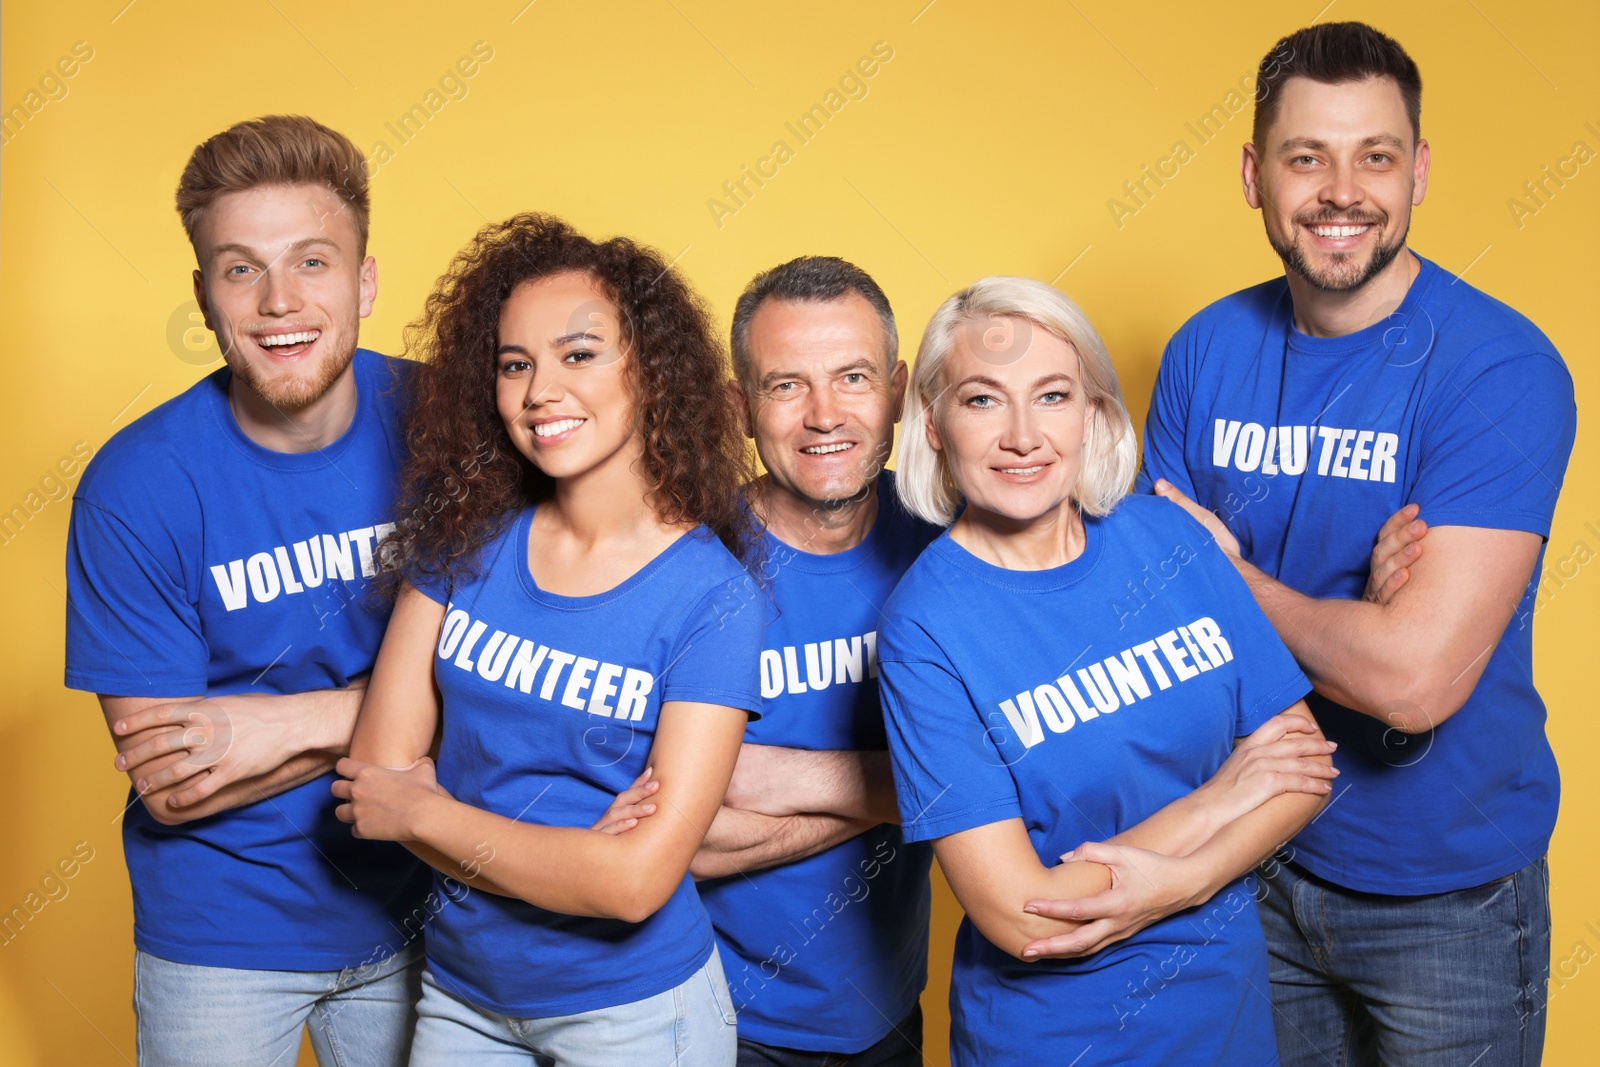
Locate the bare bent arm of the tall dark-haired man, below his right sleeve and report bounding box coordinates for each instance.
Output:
[1157,482,1542,733]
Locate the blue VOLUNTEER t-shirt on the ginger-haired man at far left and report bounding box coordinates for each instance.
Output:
[66,349,427,971]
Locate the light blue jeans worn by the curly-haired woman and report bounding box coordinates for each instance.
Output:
[411,949,736,1067]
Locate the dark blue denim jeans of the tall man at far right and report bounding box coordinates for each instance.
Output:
[1259,856,1550,1067]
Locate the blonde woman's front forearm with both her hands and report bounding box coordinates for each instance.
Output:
[1024,701,1338,957]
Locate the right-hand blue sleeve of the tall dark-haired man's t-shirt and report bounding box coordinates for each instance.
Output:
[1411,354,1578,537]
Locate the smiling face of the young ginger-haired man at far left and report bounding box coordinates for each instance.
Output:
[195,184,378,413]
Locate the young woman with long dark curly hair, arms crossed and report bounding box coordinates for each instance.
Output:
[334,214,762,1065]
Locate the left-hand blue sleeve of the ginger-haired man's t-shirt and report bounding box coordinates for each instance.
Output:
[66,498,210,697]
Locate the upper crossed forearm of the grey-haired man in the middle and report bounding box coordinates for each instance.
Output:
[723,744,899,825]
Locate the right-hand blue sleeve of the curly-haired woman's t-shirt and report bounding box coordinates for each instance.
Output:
[661,574,766,718]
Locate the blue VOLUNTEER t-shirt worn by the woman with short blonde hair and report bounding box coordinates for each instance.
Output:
[878,498,1310,1067]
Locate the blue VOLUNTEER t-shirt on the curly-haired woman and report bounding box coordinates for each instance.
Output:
[422,507,762,1017]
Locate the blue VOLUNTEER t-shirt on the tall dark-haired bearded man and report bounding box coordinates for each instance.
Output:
[1126,259,1578,894]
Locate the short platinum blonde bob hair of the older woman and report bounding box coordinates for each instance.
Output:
[896,277,1139,526]
